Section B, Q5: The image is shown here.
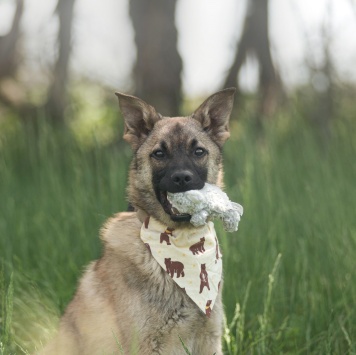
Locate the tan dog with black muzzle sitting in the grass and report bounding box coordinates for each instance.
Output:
[42,88,235,355]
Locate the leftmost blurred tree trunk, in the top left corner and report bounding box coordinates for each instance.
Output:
[0,0,24,79]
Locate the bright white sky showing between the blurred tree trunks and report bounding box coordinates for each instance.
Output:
[0,0,356,95]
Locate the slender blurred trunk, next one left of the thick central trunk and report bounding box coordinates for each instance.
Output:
[45,0,75,124]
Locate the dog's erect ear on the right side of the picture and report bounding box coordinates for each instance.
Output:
[192,88,236,146]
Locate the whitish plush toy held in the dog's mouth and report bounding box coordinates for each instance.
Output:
[167,184,243,232]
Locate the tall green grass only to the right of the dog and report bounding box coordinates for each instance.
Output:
[223,113,356,354]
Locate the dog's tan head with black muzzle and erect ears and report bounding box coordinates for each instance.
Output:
[116,88,235,228]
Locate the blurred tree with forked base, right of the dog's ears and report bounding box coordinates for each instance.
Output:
[224,0,282,117]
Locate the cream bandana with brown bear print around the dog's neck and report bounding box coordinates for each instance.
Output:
[141,217,222,317]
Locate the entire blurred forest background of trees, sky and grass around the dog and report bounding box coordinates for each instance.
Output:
[0,0,356,354]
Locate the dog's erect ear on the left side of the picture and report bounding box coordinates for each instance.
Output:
[115,92,162,149]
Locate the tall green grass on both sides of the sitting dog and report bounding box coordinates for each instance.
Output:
[0,107,356,354]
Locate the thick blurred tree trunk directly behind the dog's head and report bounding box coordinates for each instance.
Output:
[130,0,182,115]
